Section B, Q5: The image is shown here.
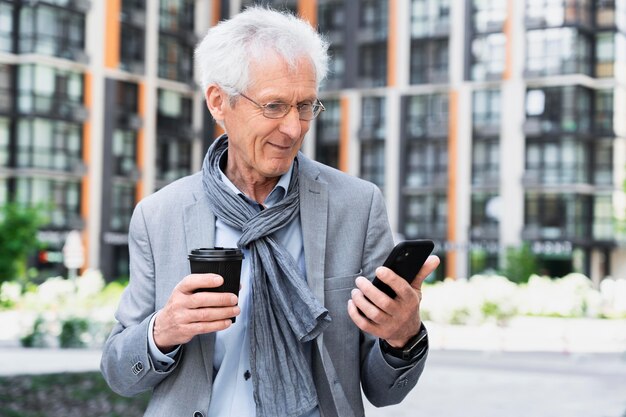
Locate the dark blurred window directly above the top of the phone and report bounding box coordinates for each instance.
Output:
[402,193,448,240]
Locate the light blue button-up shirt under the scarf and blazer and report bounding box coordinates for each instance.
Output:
[148,165,320,417]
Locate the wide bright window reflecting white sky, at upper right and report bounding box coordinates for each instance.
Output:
[526,28,591,77]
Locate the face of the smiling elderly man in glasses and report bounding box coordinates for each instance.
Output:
[223,57,317,178]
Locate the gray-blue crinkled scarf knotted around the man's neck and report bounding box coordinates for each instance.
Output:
[202,135,330,417]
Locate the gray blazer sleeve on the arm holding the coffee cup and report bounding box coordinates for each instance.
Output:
[100,203,177,396]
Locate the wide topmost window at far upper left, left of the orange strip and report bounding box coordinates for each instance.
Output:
[19,2,85,60]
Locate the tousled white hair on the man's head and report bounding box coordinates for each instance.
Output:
[195,6,328,96]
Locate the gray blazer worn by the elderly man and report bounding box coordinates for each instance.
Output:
[101,154,425,417]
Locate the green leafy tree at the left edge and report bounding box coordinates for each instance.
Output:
[0,203,45,283]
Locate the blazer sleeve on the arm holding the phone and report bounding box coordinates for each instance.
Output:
[361,189,427,407]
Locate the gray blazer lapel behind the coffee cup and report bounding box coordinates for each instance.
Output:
[183,190,215,395]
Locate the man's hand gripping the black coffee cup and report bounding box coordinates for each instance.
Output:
[153,274,241,353]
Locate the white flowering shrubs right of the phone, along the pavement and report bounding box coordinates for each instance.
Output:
[421,274,626,324]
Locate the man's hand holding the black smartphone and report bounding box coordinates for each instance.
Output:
[348,255,439,348]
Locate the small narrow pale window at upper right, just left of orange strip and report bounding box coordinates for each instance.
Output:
[471,33,506,81]
